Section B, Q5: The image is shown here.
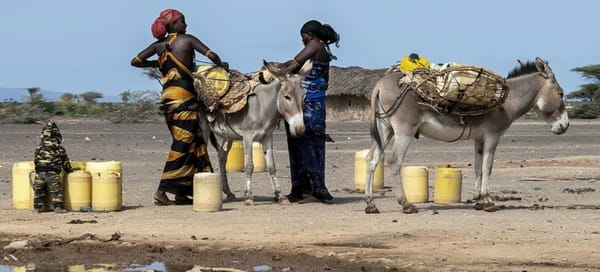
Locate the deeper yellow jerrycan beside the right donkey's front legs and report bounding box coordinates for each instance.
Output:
[433,168,462,203]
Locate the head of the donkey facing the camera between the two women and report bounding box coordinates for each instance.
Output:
[264,61,312,136]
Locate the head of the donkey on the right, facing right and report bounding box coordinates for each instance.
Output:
[534,57,569,134]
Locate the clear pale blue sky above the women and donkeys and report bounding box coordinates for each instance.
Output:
[0,0,600,95]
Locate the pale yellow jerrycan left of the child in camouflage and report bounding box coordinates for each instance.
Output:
[12,161,35,210]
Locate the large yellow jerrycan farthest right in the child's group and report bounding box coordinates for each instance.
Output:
[86,161,123,211]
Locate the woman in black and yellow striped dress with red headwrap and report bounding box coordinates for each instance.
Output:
[131,9,229,205]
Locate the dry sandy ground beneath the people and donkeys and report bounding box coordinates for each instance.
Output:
[0,120,600,271]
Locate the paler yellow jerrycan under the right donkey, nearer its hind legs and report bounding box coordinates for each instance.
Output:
[401,166,429,203]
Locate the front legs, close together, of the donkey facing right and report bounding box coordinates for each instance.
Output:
[475,137,499,212]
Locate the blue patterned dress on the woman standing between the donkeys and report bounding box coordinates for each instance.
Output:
[286,61,333,200]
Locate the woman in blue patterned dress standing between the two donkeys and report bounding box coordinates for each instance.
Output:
[283,20,340,202]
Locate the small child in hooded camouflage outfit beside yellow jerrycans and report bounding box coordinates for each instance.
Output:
[33,120,73,213]
